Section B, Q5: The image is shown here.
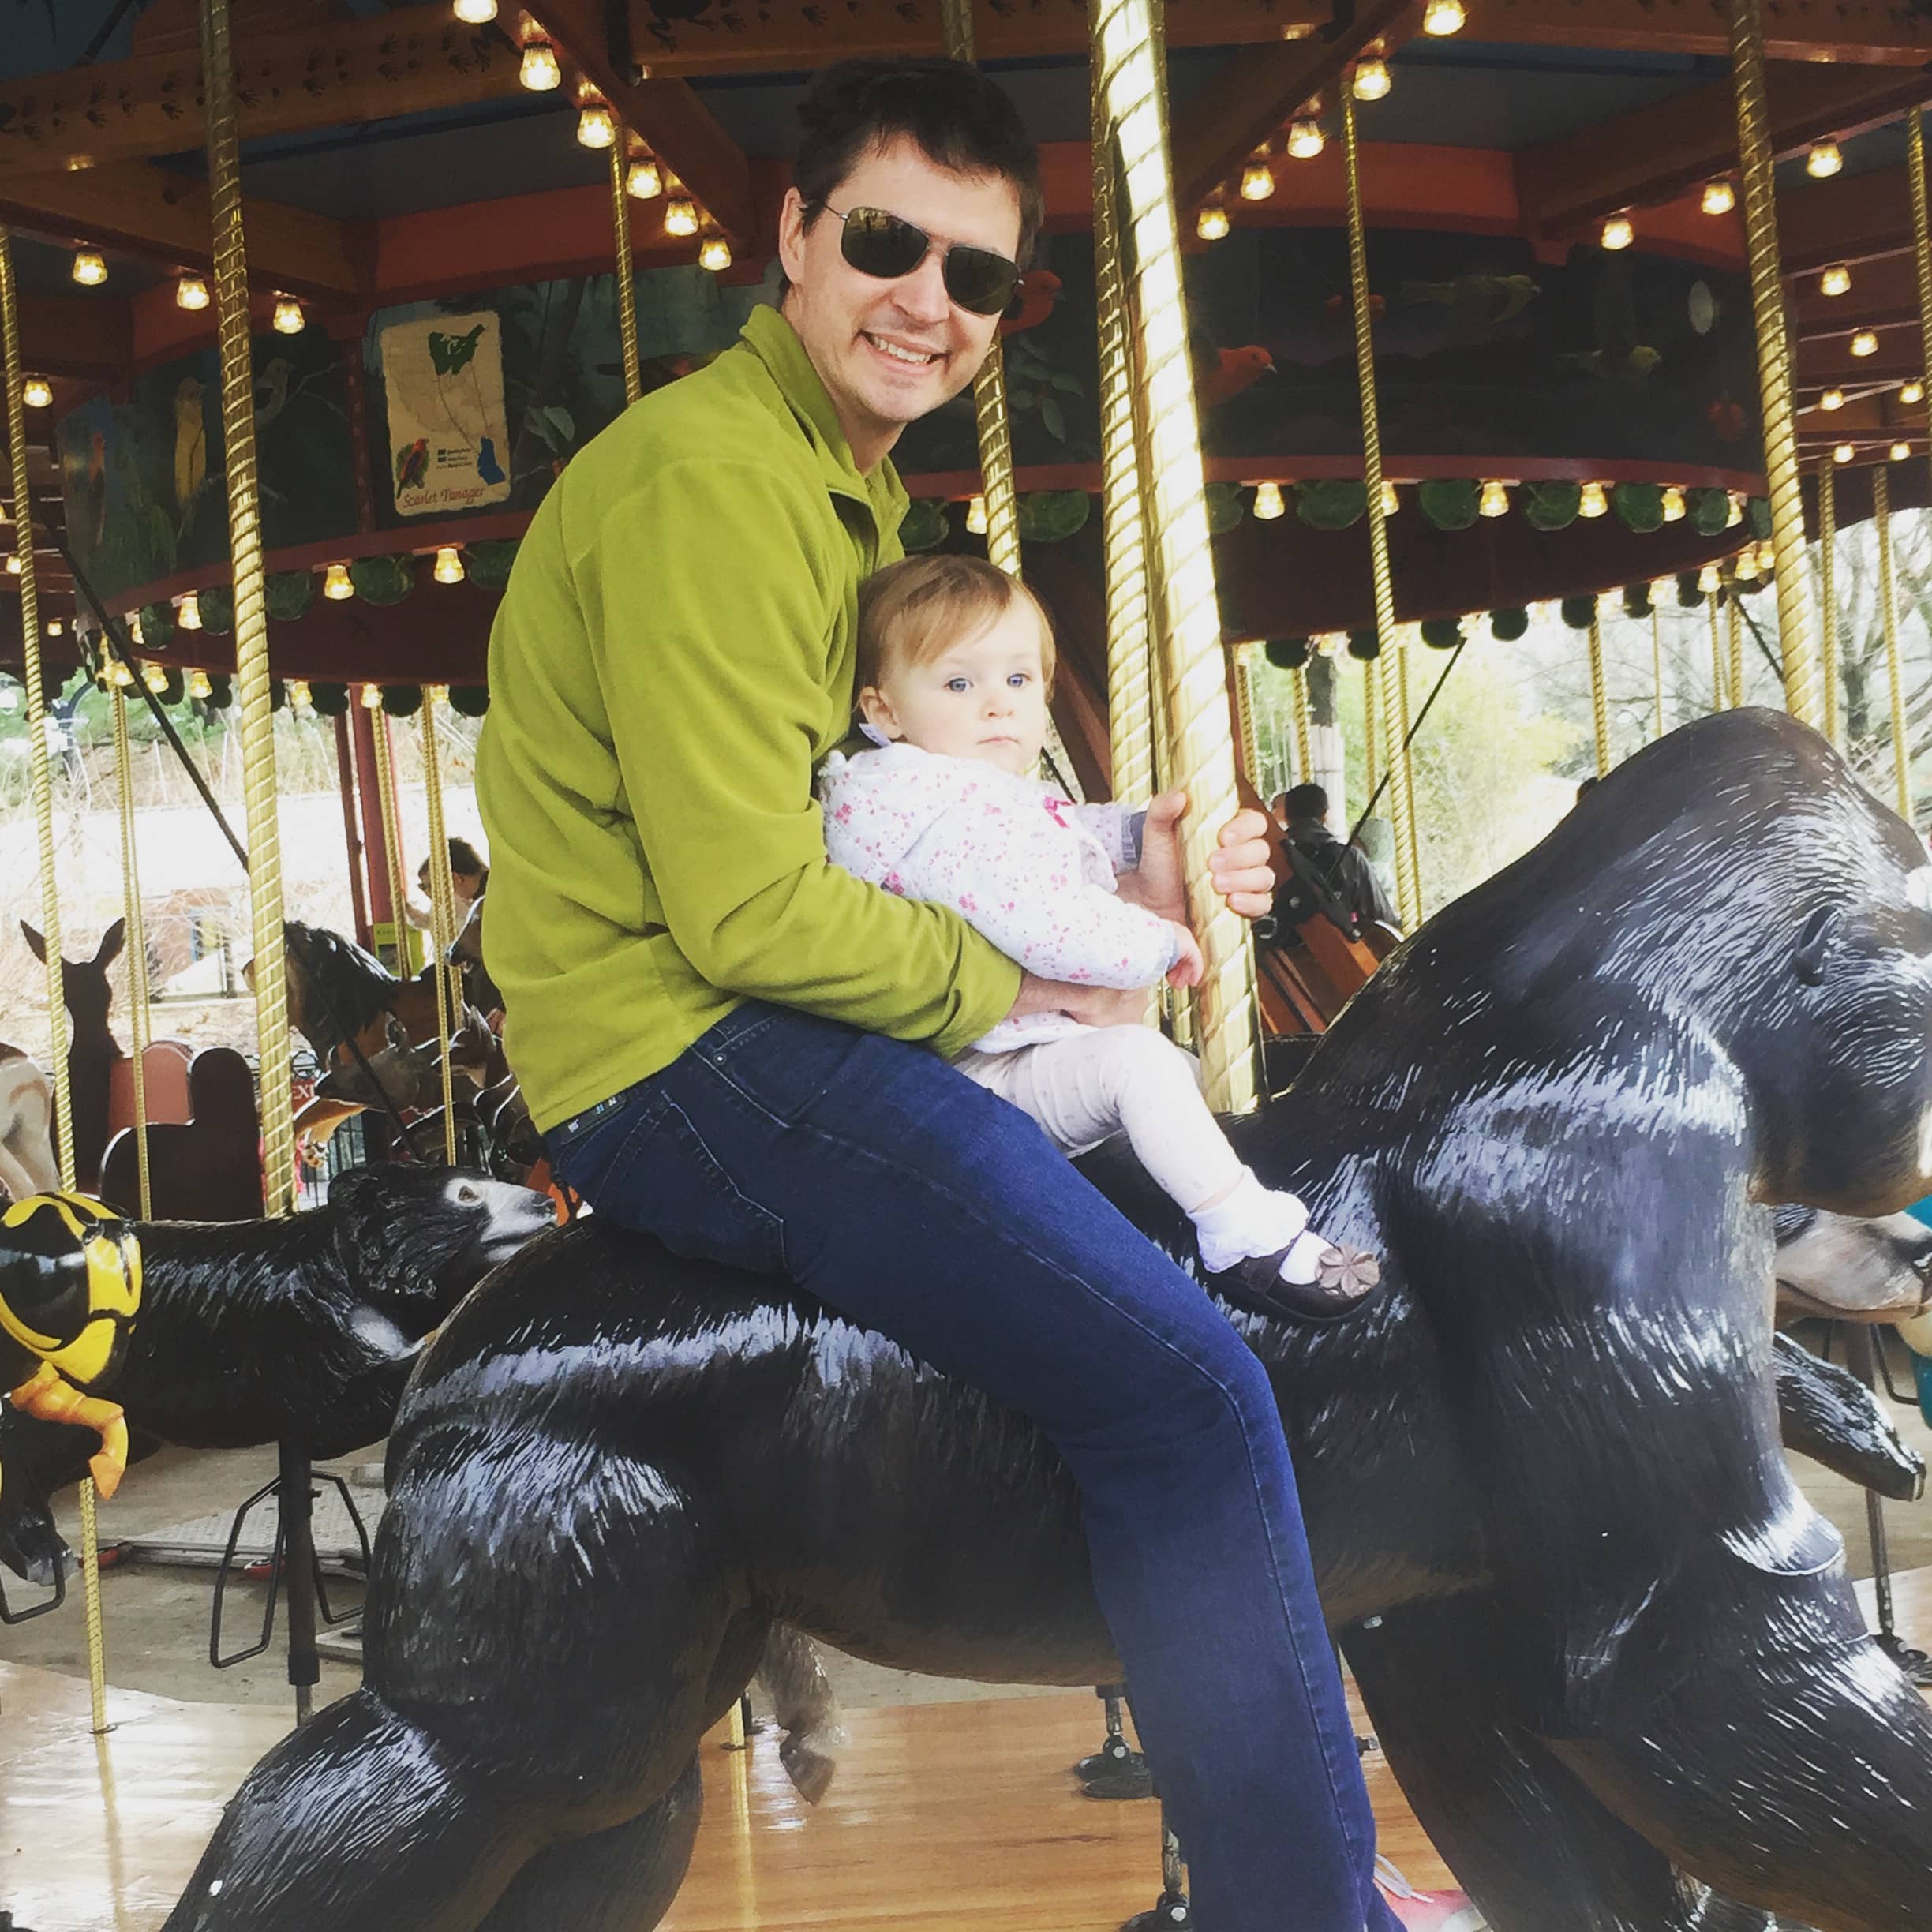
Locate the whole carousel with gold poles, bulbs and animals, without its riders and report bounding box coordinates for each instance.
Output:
[0,0,1932,1932]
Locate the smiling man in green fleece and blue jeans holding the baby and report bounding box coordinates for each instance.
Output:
[477,62,1395,1932]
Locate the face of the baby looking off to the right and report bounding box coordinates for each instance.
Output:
[859,603,1047,777]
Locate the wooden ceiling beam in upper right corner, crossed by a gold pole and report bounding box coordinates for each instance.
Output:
[1515,62,1932,236]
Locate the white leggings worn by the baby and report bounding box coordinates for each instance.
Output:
[954,1026,1241,1213]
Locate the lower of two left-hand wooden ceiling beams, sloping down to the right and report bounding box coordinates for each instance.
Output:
[0,160,375,301]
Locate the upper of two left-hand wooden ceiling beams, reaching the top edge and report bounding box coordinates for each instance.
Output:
[0,0,518,178]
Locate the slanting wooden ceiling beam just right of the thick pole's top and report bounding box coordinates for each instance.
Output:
[1174,0,1422,216]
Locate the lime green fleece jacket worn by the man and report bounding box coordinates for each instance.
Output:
[477,307,1020,1129]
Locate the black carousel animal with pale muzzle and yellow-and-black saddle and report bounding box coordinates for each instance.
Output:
[0,1167,555,1580]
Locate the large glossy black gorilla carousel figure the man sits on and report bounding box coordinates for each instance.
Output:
[168,711,1932,1932]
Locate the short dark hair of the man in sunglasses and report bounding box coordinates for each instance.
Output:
[792,60,1045,268]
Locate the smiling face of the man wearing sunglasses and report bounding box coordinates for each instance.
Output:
[779,139,1020,470]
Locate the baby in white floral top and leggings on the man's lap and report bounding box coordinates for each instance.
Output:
[819,556,1380,1321]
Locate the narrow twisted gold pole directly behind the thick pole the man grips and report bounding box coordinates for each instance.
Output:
[1091,72,1153,799]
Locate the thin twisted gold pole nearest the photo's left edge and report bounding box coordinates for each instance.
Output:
[0,228,108,1737]
